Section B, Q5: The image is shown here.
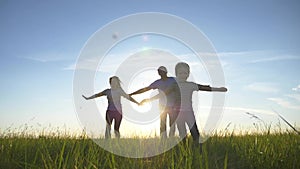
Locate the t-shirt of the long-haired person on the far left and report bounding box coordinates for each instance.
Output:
[103,88,129,113]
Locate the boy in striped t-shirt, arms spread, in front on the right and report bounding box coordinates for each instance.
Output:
[141,62,227,146]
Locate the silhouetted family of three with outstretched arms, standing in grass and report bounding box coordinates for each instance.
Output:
[82,62,227,143]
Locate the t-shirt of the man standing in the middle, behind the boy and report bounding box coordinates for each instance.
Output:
[149,77,176,107]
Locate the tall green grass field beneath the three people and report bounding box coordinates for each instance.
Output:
[0,131,300,169]
